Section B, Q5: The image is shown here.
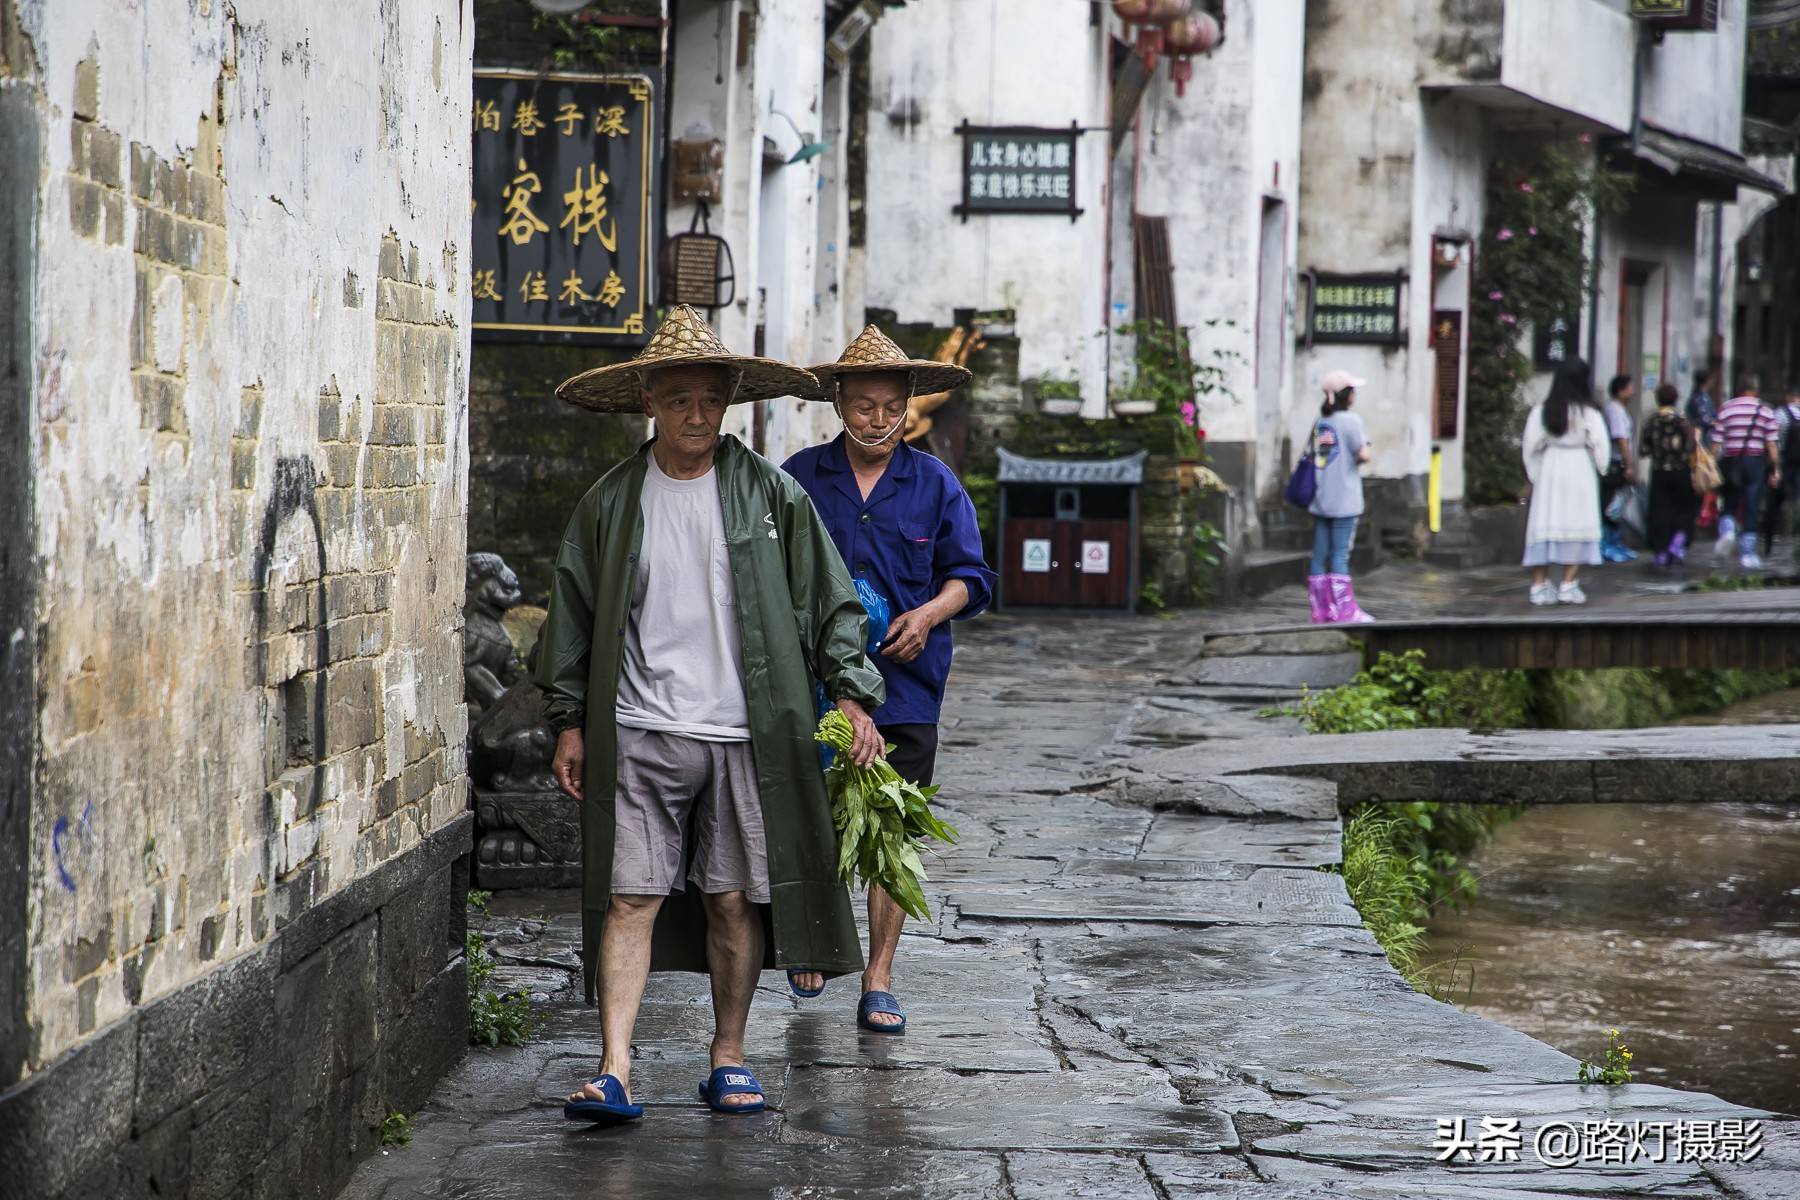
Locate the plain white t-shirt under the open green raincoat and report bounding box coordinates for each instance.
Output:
[617,453,751,741]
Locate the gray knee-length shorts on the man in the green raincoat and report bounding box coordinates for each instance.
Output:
[612,725,769,905]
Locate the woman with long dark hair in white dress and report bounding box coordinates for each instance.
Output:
[1523,358,1613,604]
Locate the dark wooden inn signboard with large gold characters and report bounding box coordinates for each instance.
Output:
[470,70,661,345]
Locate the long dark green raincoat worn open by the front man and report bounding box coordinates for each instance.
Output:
[536,435,884,1004]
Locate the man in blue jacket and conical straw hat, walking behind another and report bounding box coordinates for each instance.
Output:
[783,326,994,1033]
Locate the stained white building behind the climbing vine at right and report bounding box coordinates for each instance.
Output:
[1287,0,1785,539]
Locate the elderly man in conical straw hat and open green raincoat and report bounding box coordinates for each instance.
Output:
[536,306,884,1124]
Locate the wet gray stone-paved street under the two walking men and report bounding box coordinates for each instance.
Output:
[346,569,1800,1200]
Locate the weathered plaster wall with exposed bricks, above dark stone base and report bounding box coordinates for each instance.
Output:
[20,0,473,1067]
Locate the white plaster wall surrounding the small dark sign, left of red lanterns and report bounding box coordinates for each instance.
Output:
[866,0,1108,416]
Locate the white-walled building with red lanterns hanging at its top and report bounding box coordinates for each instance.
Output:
[866,0,1303,521]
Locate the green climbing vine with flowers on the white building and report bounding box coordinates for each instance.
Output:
[1463,143,1631,504]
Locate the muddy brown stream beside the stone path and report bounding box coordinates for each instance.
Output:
[1429,691,1800,1114]
